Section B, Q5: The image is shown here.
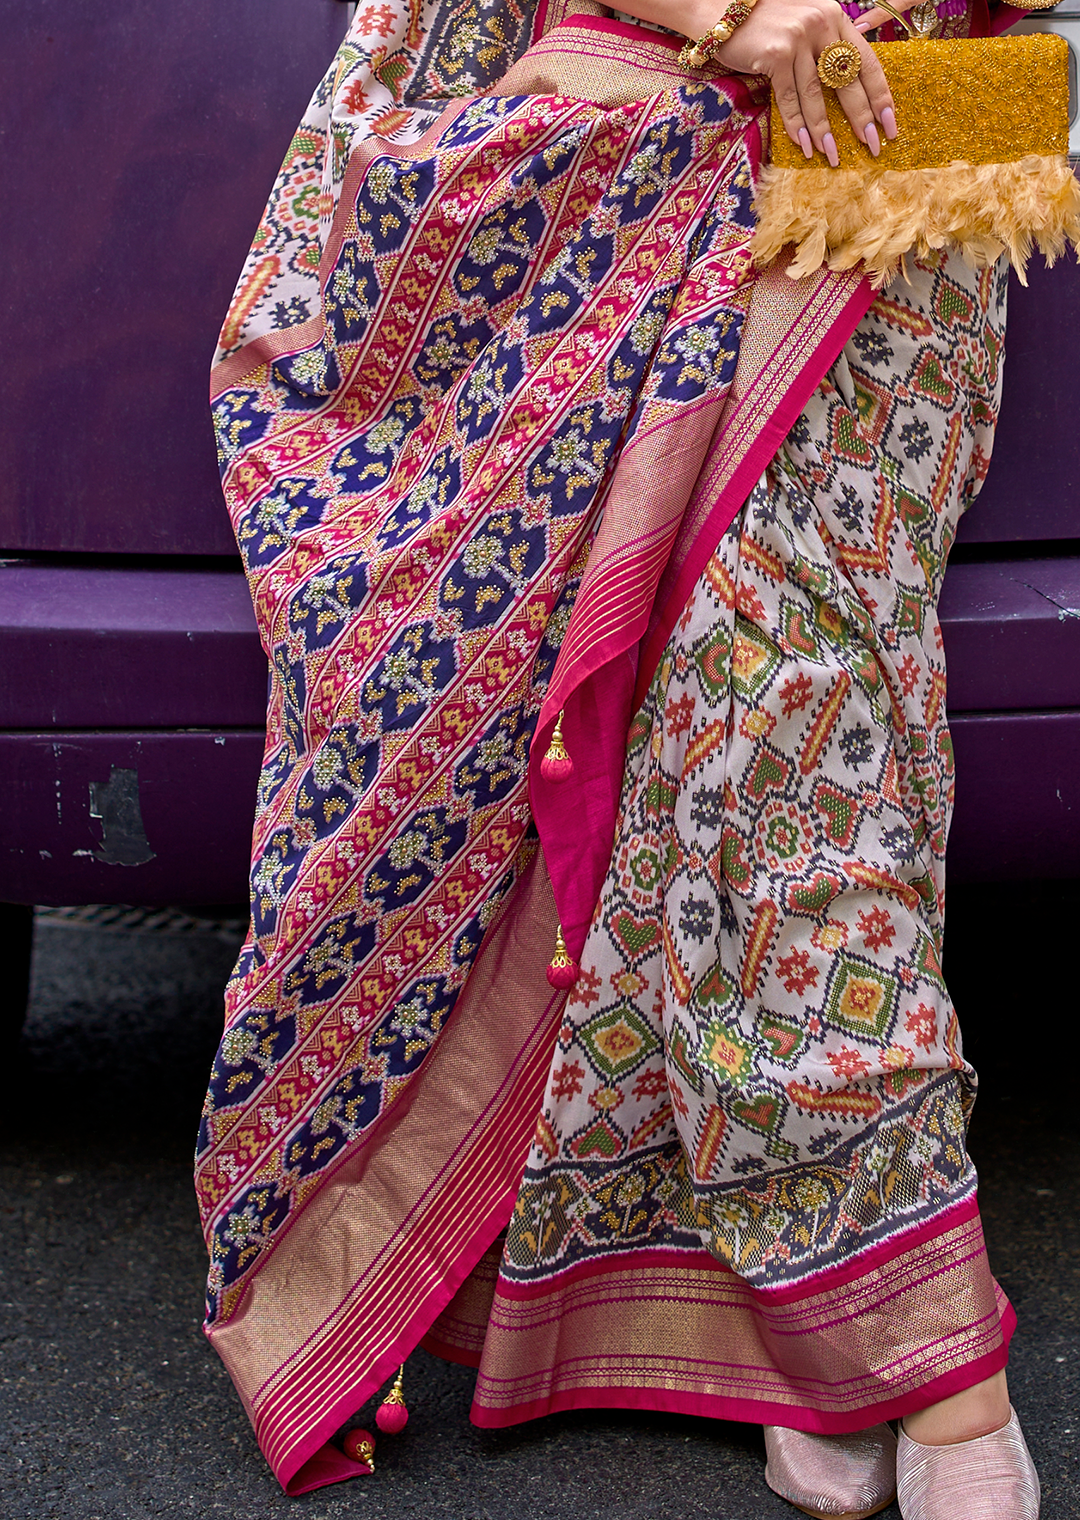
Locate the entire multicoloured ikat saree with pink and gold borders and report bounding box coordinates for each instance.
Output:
[197,0,1012,1493]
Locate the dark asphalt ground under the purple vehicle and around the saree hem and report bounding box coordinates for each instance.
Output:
[0,883,1080,1520]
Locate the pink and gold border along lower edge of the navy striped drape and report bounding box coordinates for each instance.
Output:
[208,856,565,1494]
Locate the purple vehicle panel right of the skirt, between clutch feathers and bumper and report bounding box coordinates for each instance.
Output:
[960,254,1080,543]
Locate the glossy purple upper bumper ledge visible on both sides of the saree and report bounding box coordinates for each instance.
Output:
[8,559,1080,730]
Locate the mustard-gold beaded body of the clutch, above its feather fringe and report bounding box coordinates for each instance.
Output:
[772,32,1069,173]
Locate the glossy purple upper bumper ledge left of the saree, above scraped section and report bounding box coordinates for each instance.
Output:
[0,564,266,730]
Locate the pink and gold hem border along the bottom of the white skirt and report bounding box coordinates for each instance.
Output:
[472,1199,1015,1435]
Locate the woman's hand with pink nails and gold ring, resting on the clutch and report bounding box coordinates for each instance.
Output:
[717,0,911,169]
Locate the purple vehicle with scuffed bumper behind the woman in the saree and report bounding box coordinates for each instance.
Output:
[0,0,1080,1031]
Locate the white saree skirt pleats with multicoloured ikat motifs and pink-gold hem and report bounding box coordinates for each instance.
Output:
[467,257,1013,1433]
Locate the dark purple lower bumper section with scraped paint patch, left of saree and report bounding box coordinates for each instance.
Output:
[0,730,263,904]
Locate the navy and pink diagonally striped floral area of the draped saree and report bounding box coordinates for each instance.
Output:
[197,82,765,1318]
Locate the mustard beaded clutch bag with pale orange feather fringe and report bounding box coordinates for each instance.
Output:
[753,33,1080,286]
